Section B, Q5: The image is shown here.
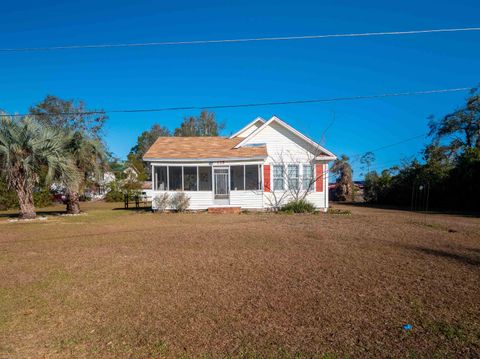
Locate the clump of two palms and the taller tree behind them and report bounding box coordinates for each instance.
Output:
[0,95,107,219]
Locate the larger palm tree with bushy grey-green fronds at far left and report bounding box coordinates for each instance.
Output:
[0,115,77,219]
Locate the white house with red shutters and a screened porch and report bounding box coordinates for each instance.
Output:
[143,116,336,210]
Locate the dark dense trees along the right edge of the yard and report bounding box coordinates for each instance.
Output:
[363,89,480,210]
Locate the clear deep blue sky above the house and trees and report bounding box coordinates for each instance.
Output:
[0,0,480,177]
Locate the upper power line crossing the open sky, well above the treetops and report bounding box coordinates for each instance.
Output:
[0,27,480,52]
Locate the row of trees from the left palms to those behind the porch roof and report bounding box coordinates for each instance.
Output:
[0,95,224,219]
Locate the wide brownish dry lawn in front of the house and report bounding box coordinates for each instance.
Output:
[0,203,480,358]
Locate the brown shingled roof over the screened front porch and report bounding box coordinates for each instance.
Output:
[143,137,267,160]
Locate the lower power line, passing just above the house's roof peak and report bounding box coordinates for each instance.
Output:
[0,87,471,117]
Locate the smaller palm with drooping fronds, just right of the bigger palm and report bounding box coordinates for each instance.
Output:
[66,131,107,214]
